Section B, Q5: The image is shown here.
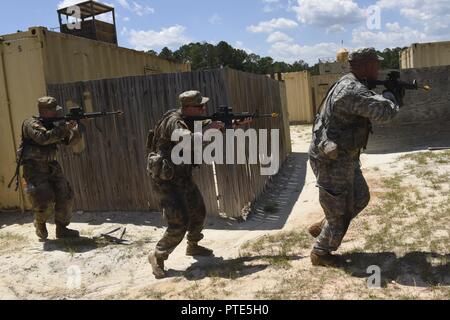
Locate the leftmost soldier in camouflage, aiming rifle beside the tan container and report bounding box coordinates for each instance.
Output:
[19,97,81,240]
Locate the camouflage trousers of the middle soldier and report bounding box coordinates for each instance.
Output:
[152,179,206,260]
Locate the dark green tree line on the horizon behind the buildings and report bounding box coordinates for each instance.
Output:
[148,41,404,75]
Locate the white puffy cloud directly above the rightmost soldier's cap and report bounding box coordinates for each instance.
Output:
[352,22,429,50]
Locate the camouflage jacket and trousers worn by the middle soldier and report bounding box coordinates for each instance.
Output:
[151,110,206,260]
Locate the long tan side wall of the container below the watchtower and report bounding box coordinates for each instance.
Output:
[39,29,190,84]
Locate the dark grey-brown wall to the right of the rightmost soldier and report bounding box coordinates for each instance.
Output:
[368,66,450,153]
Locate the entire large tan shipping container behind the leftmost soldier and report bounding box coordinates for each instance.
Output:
[0,27,190,210]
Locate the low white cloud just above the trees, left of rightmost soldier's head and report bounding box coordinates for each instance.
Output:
[269,42,340,65]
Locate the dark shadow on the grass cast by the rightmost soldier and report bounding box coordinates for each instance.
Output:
[339,252,450,287]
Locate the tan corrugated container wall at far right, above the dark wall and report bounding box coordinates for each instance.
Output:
[400,41,450,69]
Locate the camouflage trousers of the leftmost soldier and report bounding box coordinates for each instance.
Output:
[23,161,74,226]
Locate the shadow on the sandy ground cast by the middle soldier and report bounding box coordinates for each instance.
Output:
[167,256,305,281]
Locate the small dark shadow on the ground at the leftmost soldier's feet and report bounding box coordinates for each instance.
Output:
[43,237,109,253]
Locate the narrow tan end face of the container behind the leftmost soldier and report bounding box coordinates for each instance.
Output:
[0,29,46,209]
